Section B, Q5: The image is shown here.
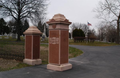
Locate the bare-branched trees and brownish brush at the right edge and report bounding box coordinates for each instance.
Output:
[94,0,120,44]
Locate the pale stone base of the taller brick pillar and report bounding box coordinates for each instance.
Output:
[47,63,72,71]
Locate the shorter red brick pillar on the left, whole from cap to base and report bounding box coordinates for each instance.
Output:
[23,26,41,65]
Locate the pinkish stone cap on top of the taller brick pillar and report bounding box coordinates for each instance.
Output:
[47,14,71,25]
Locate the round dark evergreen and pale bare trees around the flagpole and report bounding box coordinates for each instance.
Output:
[70,23,96,38]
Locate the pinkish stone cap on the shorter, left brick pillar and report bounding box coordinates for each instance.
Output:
[24,26,42,35]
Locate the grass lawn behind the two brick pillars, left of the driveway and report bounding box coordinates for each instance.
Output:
[0,39,83,71]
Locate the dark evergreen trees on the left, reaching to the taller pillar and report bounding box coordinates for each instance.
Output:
[0,18,48,37]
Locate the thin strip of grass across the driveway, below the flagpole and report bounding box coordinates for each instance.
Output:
[69,40,118,46]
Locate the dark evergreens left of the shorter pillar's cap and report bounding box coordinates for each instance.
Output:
[0,18,29,35]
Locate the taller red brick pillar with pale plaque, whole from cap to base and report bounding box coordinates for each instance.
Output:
[47,14,72,71]
